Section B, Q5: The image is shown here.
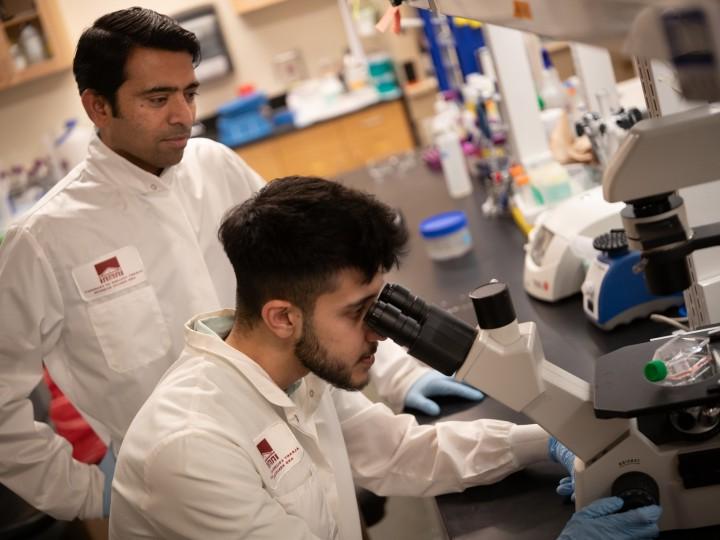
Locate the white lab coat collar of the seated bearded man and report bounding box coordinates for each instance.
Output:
[185,309,327,414]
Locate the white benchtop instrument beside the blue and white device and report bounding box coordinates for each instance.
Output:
[523,186,623,302]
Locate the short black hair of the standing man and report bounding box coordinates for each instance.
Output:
[73,7,200,114]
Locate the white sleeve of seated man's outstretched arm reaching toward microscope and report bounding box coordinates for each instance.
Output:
[332,390,549,496]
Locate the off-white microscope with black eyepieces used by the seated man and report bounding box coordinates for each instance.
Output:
[366,71,720,530]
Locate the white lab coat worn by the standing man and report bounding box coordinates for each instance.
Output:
[0,134,434,519]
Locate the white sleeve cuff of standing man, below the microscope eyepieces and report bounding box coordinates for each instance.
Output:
[371,339,432,412]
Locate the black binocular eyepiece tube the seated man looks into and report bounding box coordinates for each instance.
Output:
[365,284,477,375]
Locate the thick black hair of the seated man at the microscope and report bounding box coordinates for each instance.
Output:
[218,176,408,327]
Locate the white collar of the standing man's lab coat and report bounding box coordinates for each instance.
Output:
[86,134,177,193]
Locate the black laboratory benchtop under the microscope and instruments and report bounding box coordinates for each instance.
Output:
[337,156,720,540]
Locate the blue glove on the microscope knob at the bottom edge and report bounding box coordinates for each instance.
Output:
[557,497,662,540]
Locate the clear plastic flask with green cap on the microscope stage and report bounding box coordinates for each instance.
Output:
[644,336,717,386]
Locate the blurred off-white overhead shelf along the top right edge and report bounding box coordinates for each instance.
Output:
[406,0,720,101]
